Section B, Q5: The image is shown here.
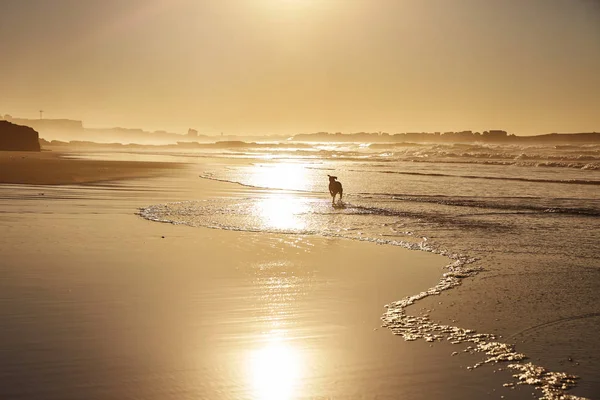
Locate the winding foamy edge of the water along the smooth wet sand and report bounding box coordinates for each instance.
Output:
[140,191,586,400]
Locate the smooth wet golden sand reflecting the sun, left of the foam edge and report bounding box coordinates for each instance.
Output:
[0,152,548,399]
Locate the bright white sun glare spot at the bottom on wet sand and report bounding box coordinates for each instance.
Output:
[249,334,304,400]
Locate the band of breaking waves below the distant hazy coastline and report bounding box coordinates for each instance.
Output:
[168,141,600,170]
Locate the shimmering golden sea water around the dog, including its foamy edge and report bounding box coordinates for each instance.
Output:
[138,142,600,399]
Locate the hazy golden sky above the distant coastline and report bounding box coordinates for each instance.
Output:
[0,0,600,135]
